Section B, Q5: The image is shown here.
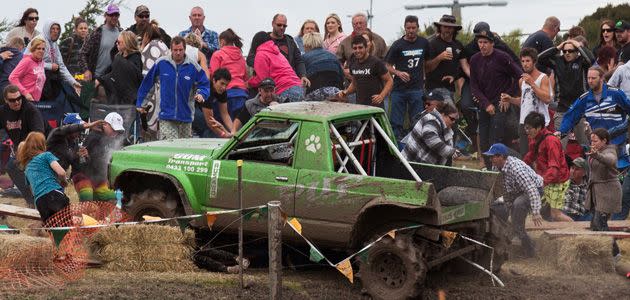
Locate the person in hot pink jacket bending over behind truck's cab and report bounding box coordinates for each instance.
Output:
[249,31,304,102]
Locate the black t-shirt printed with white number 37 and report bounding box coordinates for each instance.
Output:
[385,37,429,90]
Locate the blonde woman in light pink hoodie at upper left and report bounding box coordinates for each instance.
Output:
[9,38,46,101]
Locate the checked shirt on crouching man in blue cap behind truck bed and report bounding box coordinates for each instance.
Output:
[501,156,543,215]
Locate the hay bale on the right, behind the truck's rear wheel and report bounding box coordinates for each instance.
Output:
[538,234,615,275]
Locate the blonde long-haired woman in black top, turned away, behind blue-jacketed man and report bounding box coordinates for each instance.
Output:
[95,31,142,105]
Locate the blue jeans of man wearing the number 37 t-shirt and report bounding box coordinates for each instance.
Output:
[389,89,424,141]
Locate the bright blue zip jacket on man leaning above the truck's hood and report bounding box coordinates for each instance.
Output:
[136,55,210,123]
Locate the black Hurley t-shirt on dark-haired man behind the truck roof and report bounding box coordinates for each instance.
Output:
[349,55,388,106]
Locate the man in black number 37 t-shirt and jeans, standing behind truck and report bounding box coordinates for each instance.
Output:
[385,16,429,141]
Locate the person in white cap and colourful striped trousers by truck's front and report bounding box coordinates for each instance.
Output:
[72,112,126,201]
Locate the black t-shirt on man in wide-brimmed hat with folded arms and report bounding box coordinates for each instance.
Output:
[425,36,464,91]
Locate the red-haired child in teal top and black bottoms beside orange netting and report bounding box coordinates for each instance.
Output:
[17,132,70,224]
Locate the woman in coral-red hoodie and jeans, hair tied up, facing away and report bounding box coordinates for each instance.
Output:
[210,28,249,131]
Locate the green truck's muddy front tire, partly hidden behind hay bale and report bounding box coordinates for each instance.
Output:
[124,189,183,221]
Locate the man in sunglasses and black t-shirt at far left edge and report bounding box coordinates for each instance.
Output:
[0,84,44,207]
